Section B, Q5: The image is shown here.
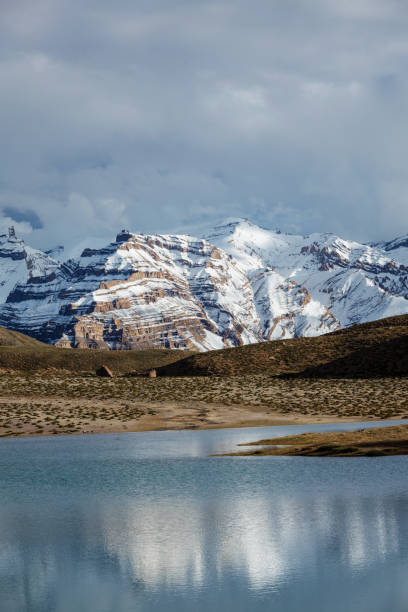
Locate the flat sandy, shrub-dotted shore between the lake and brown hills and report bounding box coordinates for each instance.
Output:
[0,372,408,437]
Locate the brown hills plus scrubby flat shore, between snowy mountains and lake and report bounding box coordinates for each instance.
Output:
[0,315,408,436]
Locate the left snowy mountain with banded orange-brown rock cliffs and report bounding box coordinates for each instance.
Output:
[0,232,262,350]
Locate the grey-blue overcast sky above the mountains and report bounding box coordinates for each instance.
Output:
[0,0,408,249]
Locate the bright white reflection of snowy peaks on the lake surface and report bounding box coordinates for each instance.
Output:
[99,496,399,589]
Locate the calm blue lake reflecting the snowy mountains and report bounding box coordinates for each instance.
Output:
[0,423,408,612]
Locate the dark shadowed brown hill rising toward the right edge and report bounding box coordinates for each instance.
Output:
[158,315,408,377]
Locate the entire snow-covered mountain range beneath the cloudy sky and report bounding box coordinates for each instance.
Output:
[0,219,408,350]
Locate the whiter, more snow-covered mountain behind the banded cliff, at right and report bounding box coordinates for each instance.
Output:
[207,221,408,339]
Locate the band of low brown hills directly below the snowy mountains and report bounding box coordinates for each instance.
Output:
[0,315,408,378]
